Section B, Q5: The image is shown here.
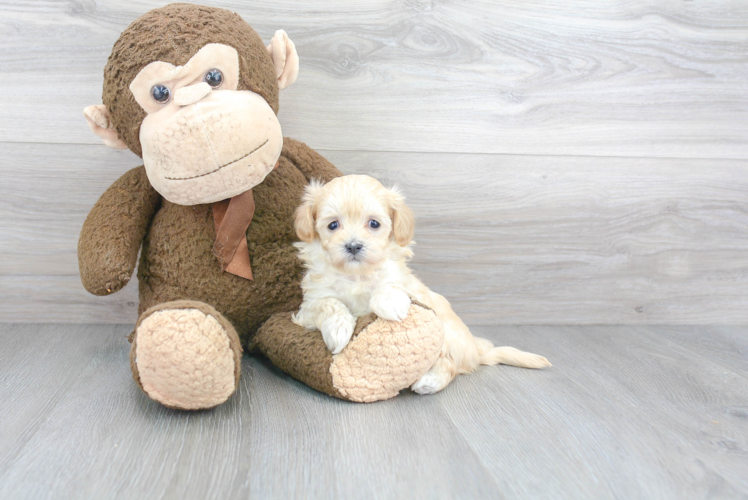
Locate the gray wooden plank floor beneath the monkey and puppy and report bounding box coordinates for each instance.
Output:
[0,324,748,499]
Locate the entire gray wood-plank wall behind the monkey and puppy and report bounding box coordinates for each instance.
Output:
[0,0,748,324]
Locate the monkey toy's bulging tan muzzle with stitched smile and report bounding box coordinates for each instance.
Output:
[140,90,283,205]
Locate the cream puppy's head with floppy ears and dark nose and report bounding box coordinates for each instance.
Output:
[295,175,415,274]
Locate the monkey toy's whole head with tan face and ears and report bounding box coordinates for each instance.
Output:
[84,4,299,205]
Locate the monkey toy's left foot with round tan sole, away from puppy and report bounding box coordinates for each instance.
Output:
[130,300,242,410]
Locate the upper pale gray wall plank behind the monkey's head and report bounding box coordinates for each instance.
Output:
[0,0,748,159]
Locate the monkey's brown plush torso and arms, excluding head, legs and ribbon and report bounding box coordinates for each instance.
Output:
[78,138,340,342]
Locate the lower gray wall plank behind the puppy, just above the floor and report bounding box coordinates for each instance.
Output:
[0,143,748,324]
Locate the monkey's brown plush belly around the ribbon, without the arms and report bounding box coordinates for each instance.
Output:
[138,157,306,344]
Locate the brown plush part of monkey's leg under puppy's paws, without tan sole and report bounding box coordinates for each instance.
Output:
[249,312,377,399]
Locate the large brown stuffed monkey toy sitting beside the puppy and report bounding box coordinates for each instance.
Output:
[78,4,443,410]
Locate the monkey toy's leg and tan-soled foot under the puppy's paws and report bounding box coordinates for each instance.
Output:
[254,302,444,403]
